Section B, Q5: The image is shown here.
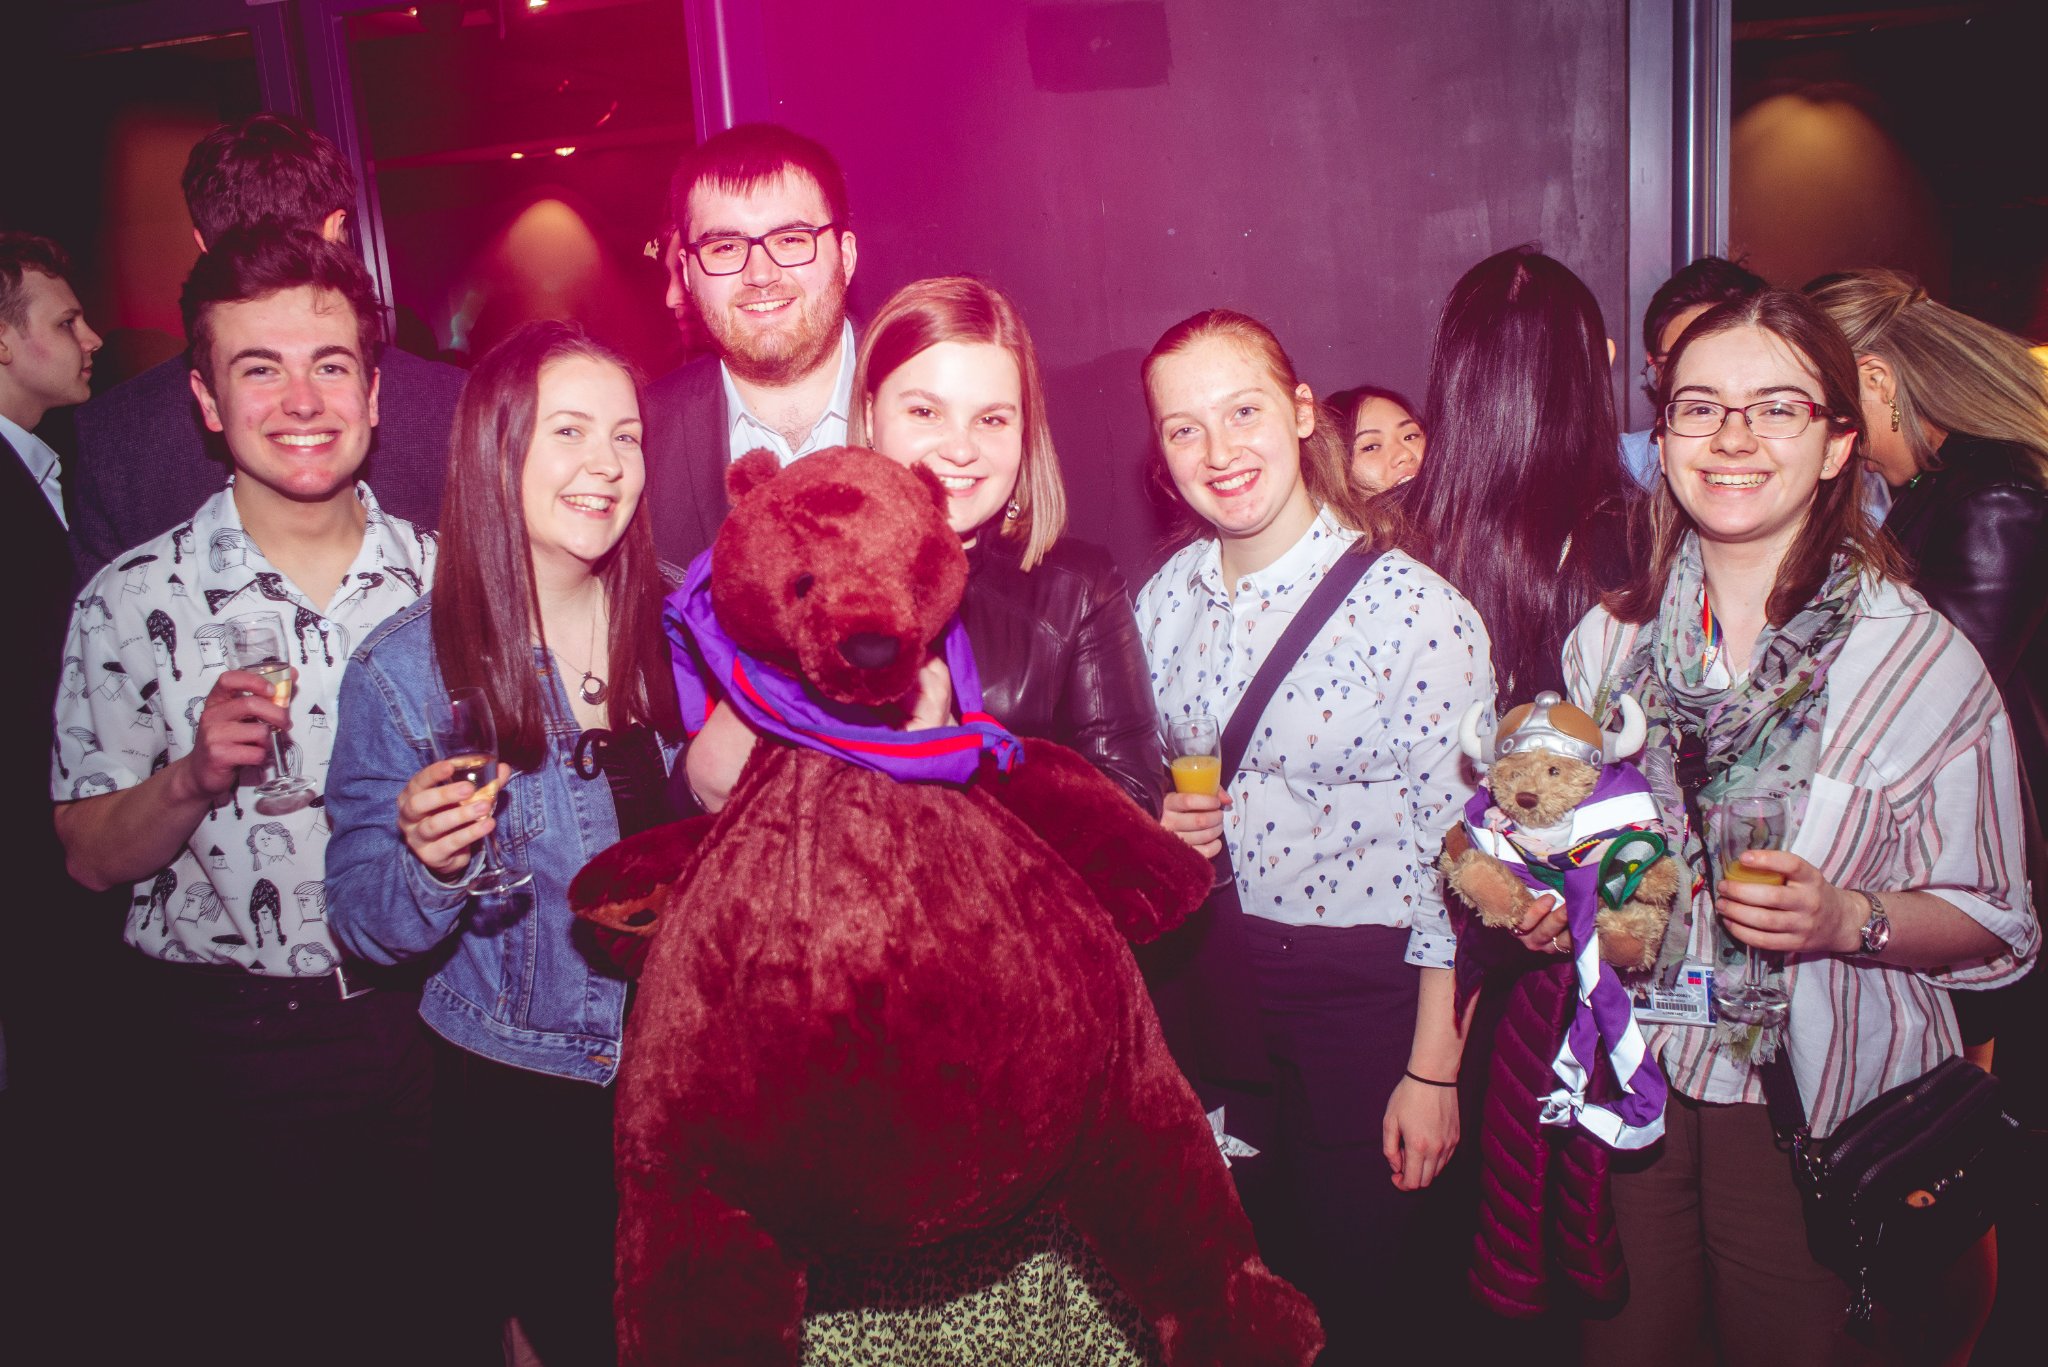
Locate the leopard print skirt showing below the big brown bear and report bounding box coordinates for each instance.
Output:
[803,1211,1159,1367]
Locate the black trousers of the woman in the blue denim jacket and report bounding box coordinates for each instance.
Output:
[434,1041,618,1367]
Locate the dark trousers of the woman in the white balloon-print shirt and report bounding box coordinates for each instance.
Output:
[1241,916,1432,1367]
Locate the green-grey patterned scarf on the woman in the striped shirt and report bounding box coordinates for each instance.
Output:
[1608,535,1860,1062]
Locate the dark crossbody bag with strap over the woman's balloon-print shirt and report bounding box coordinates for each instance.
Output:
[1133,549,1380,1170]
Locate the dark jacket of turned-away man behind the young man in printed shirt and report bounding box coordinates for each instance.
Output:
[68,346,463,576]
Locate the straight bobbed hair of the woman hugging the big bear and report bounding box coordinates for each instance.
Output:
[846,275,1067,570]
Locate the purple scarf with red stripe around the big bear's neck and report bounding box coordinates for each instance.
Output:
[662,551,1024,783]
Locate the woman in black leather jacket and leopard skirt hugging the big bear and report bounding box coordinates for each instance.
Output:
[712,277,1165,1367]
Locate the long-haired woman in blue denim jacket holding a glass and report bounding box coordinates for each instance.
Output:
[328,322,682,1363]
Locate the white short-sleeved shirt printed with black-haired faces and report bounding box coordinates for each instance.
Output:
[49,482,434,978]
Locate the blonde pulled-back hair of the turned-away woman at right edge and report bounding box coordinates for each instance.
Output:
[1812,271,2048,486]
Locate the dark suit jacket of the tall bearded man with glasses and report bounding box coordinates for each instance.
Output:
[645,353,733,570]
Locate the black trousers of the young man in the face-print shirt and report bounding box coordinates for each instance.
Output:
[92,953,444,1367]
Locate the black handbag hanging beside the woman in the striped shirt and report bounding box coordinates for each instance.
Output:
[1761,1032,2019,1338]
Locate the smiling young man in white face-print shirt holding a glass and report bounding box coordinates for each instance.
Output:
[51,230,448,1363]
